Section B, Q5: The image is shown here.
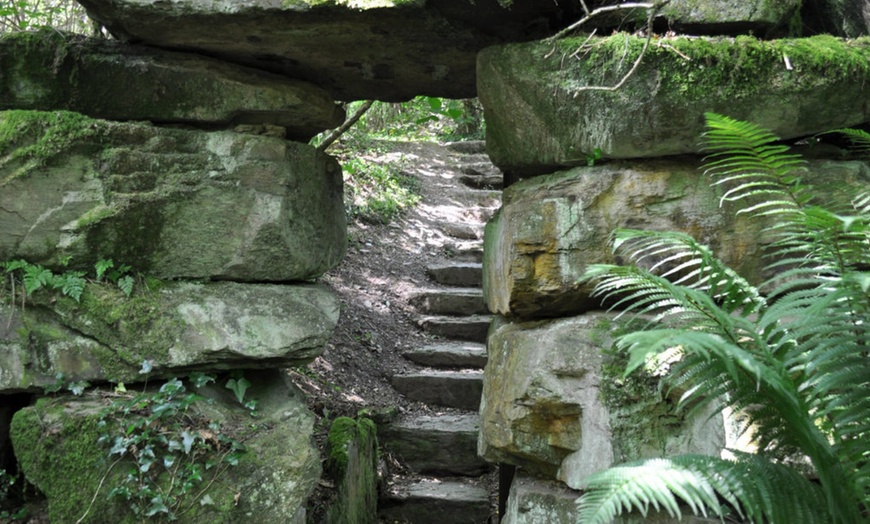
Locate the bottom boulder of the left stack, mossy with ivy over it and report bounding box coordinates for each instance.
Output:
[11,371,321,524]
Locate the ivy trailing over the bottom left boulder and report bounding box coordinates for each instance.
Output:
[100,373,250,521]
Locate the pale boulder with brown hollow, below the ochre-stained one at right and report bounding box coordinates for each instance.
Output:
[478,313,725,489]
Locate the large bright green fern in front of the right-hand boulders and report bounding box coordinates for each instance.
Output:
[579,114,870,524]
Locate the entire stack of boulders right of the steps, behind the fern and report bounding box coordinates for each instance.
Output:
[478,10,870,524]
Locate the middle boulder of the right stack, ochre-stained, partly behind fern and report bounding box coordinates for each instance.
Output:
[483,157,870,317]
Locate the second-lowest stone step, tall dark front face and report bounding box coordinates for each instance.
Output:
[378,413,492,477]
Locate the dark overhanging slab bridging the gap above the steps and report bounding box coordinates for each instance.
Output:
[81,0,580,101]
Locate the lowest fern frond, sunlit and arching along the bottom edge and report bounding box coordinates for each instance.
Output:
[578,455,831,524]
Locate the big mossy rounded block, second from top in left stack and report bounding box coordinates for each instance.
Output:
[0,111,347,281]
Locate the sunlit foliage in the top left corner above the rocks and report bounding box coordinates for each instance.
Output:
[0,0,95,34]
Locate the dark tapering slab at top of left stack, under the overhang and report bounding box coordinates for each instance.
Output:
[0,30,344,141]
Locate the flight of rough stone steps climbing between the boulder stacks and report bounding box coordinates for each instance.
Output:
[378,143,501,524]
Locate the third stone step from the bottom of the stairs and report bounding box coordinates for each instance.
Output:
[390,370,483,411]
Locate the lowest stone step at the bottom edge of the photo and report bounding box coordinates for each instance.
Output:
[378,480,490,524]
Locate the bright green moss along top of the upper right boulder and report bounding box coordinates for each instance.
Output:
[554,33,870,100]
